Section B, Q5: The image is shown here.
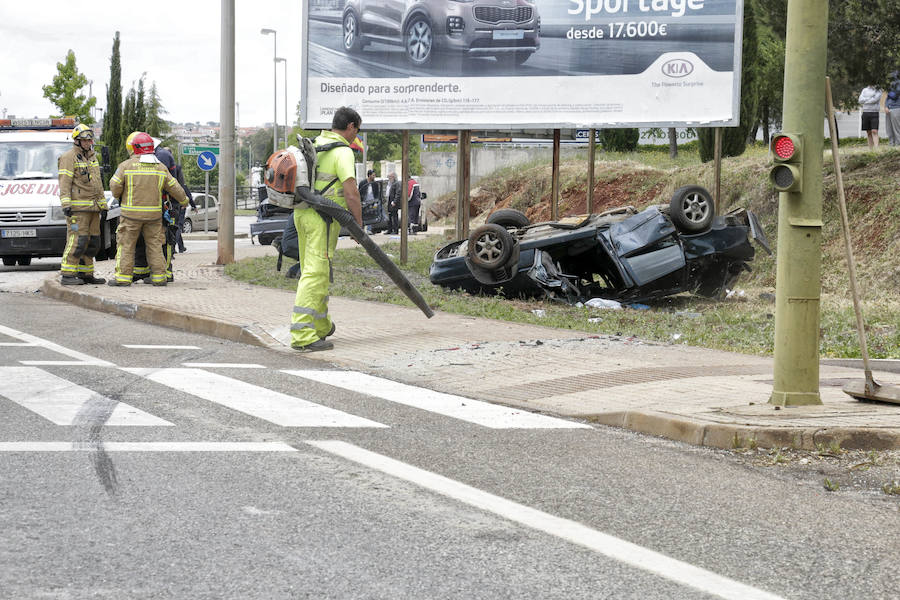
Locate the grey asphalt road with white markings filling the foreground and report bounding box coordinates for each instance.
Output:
[0,293,900,599]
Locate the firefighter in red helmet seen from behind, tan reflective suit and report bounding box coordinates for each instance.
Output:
[109,131,188,286]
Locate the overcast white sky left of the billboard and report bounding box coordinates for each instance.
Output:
[0,0,301,127]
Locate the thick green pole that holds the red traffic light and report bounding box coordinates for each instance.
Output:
[769,0,828,406]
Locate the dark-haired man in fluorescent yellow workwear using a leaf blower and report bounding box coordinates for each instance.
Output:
[291,106,362,352]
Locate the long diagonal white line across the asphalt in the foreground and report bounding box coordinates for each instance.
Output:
[306,440,780,600]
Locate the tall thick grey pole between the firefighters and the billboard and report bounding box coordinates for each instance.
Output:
[216,0,234,265]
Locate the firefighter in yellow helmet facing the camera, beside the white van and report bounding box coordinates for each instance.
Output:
[59,123,107,285]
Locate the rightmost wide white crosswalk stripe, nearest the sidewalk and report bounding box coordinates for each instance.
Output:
[283,369,591,429]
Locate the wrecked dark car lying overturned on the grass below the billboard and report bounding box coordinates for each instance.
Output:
[430,185,771,303]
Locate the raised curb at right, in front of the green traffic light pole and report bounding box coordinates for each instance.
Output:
[588,411,900,450]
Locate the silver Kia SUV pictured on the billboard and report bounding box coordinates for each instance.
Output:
[342,0,541,67]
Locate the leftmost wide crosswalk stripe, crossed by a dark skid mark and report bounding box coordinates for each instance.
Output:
[0,367,172,427]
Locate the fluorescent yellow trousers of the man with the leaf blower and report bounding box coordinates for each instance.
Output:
[291,208,341,347]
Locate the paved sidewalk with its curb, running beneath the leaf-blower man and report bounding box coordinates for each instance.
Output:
[42,239,900,450]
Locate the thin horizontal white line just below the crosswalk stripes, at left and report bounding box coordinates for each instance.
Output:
[0,442,297,452]
